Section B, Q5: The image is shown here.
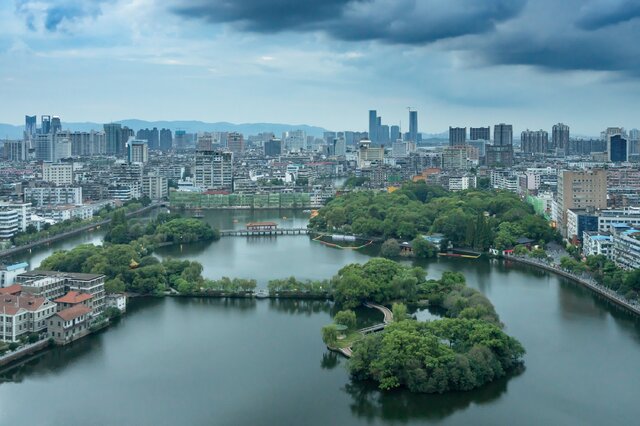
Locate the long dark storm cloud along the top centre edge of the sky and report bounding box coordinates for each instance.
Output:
[173,0,526,44]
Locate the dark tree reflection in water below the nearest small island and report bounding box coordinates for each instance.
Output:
[342,367,524,423]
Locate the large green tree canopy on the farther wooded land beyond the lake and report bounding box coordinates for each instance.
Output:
[309,183,559,250]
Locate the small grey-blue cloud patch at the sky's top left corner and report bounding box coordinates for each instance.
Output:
[16,0,111,32]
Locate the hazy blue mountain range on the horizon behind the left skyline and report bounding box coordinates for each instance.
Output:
[0,119,326,139]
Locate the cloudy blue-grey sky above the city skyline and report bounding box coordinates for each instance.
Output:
[0,0,640,135]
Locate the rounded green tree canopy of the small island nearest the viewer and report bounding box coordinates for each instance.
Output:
[348,319,525,393]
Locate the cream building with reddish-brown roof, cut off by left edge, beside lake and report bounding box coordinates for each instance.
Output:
[0,294,56,342]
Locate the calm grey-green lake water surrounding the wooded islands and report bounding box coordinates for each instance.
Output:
[0,211,640,425]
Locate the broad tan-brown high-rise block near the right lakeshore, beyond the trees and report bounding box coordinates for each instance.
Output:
[555,169,607,236]
